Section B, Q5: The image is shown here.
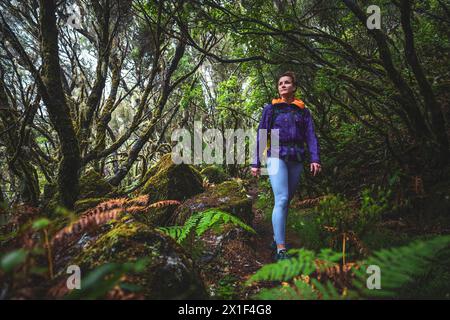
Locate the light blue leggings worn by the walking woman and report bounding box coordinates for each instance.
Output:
[267,157,303,244]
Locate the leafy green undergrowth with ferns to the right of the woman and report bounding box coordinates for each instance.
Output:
[243,178,450,299]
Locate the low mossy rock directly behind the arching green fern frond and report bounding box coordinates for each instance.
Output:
[170,180,253,225]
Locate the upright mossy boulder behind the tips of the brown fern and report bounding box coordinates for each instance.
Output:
[140,154,204,226]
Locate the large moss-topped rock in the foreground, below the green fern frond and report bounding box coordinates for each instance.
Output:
[73,221,207,299]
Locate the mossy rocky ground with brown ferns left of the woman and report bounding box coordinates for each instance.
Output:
[0,155,308,299]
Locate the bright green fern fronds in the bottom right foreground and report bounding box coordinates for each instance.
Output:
[248,235,450,300]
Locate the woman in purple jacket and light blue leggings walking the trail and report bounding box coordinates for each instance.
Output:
[251,71,321,260]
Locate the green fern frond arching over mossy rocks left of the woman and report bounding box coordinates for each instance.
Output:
[158,209,256,244]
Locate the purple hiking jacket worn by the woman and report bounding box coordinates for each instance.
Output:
[252,102,320,168]
